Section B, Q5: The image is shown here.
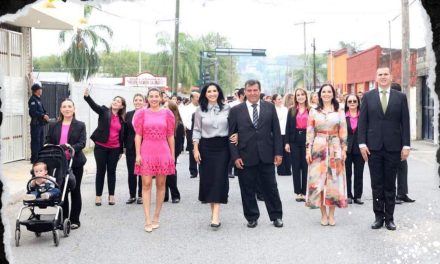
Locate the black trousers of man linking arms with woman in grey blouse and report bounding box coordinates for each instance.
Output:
[238,163,283,221]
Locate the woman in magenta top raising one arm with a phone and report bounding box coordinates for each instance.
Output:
[84,88,126,206]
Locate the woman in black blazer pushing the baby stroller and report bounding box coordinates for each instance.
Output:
[45,99,87,229]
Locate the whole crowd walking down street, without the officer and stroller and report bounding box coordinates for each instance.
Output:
[28,67,410,232]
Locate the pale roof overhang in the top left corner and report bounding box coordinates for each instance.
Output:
[0,1,82,30]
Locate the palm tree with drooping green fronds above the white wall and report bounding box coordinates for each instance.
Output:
[59,5,113,82]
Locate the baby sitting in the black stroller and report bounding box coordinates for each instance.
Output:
[23,162,61,201]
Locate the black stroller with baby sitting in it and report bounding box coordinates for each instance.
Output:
[15,145,75,247]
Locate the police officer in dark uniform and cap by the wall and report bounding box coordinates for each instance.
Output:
[28,83,49,163]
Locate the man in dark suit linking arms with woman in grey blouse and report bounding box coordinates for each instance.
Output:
[229,80,283,228]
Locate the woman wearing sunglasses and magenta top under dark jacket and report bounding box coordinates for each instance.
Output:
[345,94,365,204]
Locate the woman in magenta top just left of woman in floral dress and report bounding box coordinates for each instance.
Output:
[285,88,310,202]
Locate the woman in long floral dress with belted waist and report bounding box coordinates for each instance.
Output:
[306,84,347,226]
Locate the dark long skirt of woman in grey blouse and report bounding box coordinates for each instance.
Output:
[199,137,230,204]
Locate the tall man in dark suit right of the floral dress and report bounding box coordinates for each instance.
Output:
[358,67,410,230]
